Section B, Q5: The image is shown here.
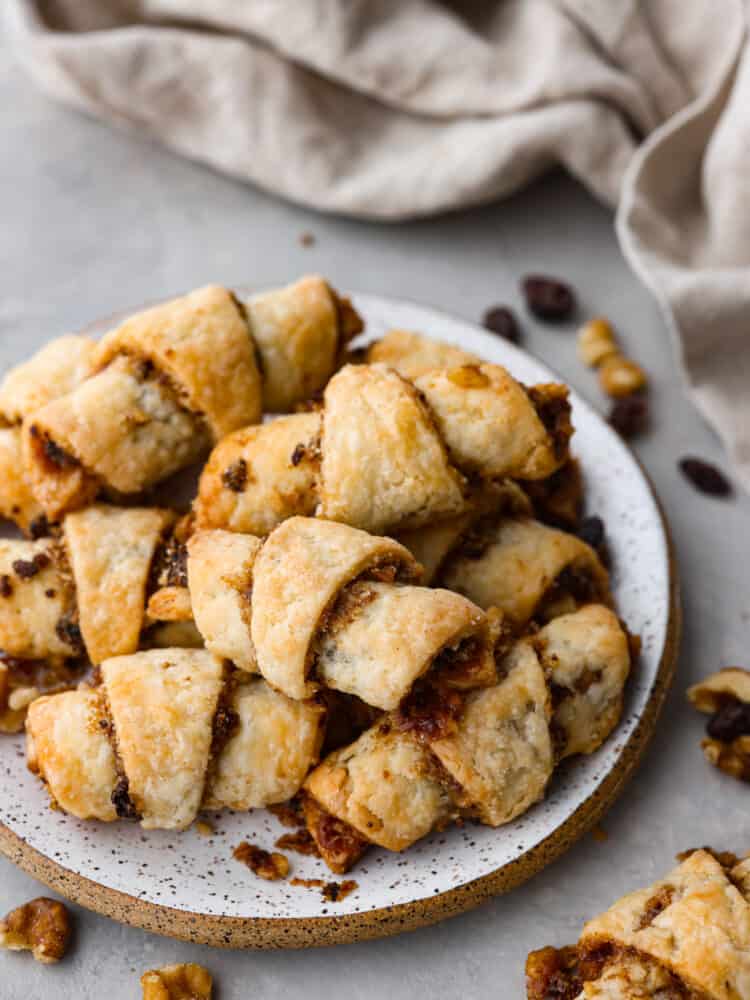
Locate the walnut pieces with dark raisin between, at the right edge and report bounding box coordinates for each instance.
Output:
[688,667,750,781]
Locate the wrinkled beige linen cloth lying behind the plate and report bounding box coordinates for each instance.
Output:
[5,0,750,488]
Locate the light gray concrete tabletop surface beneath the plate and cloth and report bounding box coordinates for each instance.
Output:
[0,29,750,1000]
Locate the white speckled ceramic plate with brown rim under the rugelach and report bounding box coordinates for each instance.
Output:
[0,295,679,947]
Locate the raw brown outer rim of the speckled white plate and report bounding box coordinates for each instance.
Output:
[0,286,682,949]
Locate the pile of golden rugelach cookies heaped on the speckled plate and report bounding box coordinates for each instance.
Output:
[0,278,637,872]
